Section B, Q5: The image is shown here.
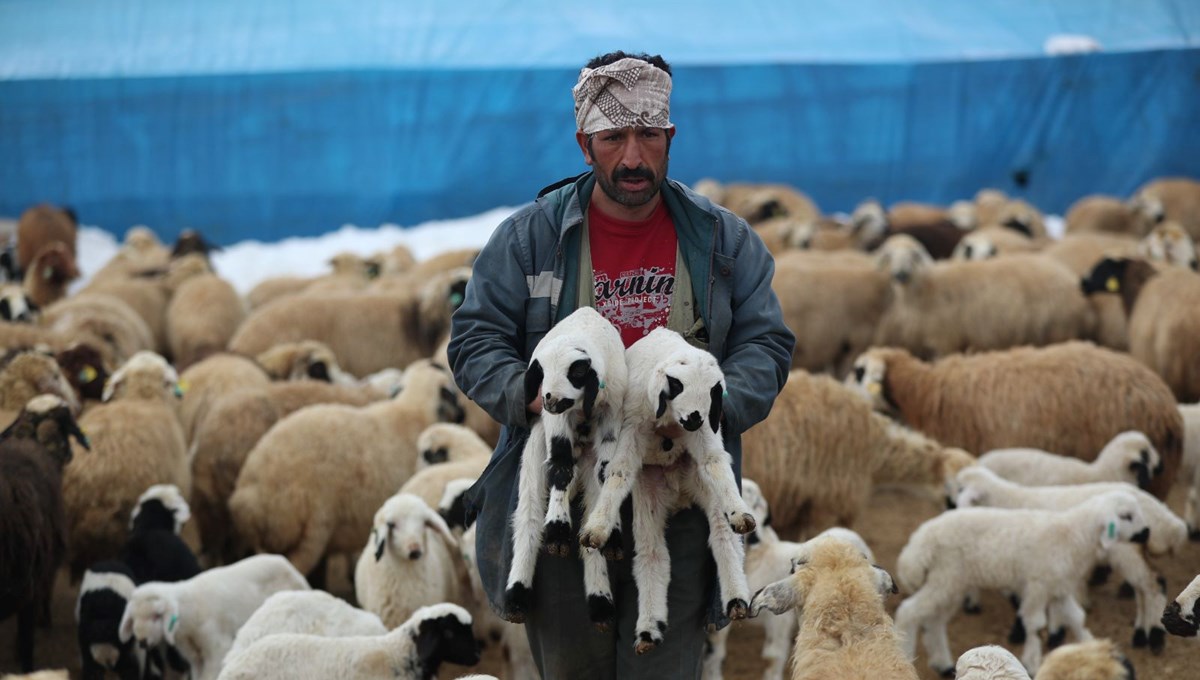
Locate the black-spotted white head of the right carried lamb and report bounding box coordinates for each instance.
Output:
[648,343,725,432]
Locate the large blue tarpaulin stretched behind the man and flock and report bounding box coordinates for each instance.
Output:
[0,0,1200,242]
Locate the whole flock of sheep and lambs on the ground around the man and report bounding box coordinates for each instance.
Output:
[0,175,1200,680]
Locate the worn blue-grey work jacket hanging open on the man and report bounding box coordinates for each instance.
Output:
[449,173,796,676]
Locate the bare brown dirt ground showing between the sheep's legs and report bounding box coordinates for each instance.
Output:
[0,485,1200,680]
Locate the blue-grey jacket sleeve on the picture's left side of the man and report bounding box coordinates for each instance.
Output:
[448,216,533,427]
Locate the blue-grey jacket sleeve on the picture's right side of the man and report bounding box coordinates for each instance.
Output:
[721,225,796,434]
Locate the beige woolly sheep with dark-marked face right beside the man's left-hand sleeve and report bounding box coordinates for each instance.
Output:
[229,269,470,377]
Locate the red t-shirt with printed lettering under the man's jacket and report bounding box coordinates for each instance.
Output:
[588,200,678,347]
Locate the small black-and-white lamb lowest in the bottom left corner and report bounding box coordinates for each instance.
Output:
[76,560,145,680]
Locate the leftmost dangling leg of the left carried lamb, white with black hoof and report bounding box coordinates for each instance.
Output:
[504,434,546,624]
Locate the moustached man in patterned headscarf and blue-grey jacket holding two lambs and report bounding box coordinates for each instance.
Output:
[449,52,794,680]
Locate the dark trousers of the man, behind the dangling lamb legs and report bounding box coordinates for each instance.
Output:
[526,501,716,680]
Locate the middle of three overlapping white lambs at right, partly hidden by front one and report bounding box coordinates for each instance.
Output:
[955,467,1188,652]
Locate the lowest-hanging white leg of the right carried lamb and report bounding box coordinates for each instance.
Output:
[634,486,672,654]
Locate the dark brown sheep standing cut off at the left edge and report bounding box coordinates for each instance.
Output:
[0,395,88,673]
